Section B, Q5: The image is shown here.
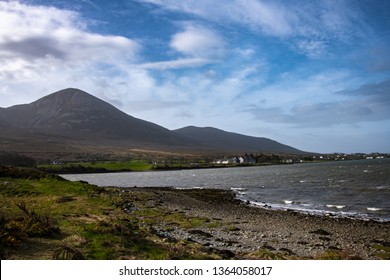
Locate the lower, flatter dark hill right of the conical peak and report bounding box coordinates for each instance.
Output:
[174,126,302,153]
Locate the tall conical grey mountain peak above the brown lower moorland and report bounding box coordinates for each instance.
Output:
[2,88,193,148]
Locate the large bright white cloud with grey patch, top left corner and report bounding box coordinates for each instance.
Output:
[0,2,140,85]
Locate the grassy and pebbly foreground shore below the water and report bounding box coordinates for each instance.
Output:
[0,167,390,259]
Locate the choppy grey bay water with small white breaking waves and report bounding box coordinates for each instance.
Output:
[63,159,390,221]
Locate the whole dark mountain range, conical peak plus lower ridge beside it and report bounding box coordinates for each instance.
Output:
[0,88,300,157]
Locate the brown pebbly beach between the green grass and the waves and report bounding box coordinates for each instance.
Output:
[124,188,390,260]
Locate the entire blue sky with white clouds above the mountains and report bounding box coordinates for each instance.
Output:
[0,0,390,153]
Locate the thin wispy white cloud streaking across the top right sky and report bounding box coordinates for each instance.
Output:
[139,0,368,58]
